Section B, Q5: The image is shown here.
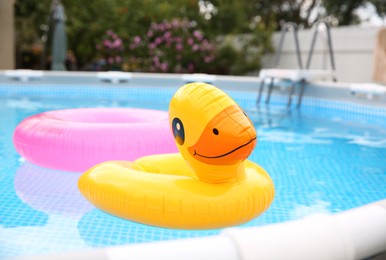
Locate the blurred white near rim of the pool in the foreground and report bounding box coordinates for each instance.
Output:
[16,200,386,260]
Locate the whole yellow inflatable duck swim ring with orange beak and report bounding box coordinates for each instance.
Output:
[78,83,274,229]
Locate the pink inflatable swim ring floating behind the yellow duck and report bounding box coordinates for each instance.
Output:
[13,108,177,172]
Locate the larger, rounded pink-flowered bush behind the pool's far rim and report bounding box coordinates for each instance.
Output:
[128,19,216,73]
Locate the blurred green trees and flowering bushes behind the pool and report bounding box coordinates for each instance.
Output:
[15,0,386,75]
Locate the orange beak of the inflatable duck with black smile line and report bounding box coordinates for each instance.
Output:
[188,105,257,165]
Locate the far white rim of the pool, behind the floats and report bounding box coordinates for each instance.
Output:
[0,70,386,106]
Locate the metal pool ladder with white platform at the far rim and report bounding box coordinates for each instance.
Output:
[257,21,336,108]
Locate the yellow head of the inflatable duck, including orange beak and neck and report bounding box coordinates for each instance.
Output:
[169,82,257,182]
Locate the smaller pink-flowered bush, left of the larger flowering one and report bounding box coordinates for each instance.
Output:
[96,30,124,70]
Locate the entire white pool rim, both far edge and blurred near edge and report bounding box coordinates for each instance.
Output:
[4,70,386,260]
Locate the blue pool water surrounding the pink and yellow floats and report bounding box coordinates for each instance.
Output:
[0,85,386,258]
